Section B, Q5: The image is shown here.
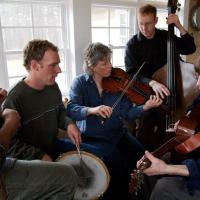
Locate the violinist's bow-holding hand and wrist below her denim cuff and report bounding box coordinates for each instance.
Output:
[88,105,113,118]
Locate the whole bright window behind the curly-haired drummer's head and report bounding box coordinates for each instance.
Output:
[0,1,70,92]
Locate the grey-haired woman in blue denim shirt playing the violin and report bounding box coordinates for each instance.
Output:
[67,43,162,200]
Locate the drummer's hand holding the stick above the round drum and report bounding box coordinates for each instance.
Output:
[67,123,81,146]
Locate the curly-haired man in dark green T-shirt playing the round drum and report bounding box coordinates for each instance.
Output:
[3,40,101,161]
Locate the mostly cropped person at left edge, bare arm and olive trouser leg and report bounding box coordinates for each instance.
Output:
[0,88,78,200]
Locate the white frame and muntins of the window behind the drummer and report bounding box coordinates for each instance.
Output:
[0,0,72,95]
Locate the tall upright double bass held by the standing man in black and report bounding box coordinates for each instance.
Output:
[152,0,200,122]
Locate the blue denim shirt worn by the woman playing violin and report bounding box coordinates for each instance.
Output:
[67,74,145,144]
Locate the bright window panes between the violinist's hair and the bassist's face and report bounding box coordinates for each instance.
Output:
[91,5,134,67]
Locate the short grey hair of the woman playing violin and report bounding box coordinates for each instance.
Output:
[83,42,112,74]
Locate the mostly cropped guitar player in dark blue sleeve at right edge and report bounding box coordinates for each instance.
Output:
[133,56,200,200]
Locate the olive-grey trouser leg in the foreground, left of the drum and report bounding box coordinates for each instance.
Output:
[2,160,78,200]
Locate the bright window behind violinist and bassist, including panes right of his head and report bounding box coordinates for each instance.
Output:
[91,0,184,68]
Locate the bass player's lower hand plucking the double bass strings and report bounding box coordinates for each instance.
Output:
[149,80,170,99]
